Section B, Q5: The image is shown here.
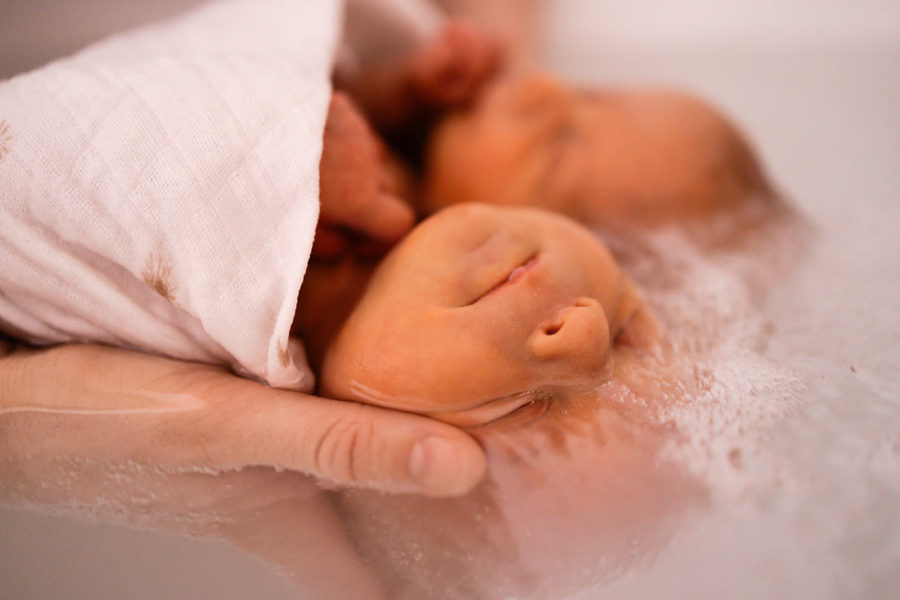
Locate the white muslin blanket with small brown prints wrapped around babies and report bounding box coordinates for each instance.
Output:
[0,0,341,390]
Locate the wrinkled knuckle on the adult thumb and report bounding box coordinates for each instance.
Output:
[314,415,375,484]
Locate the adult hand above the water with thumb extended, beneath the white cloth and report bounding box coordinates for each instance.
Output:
[0,345,485,496]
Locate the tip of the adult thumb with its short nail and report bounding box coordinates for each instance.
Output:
[409,436,485,496]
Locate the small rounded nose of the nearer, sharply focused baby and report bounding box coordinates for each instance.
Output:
[528,297,610,374]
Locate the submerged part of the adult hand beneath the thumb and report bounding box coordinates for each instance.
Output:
[0,459,382,600]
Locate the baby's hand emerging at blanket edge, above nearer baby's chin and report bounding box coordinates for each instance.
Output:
[313,92,415,258]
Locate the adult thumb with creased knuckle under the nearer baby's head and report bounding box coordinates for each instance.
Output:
[211,382,485,496]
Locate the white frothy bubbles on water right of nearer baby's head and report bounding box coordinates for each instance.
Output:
[627,230,804,498]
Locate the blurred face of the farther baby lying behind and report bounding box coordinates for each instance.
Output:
[424,75,767,225]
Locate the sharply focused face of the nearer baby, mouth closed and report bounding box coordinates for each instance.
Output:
[320,205,656,425]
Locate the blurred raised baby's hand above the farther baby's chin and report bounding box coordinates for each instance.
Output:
[337,19,503,134]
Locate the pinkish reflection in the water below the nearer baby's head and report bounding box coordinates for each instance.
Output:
[339,394,704,598]
